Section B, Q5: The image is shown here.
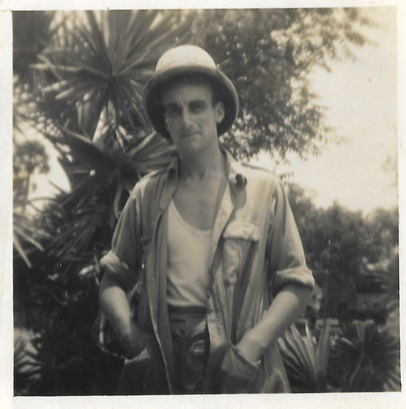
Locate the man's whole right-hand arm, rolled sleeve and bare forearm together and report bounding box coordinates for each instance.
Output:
[237,178,314,362]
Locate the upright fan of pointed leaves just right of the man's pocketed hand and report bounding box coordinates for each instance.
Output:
[278,320,331,393]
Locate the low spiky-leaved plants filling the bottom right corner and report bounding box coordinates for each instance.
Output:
[278,320,400,393]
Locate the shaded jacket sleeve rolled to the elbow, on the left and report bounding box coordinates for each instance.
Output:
[100,187,142,291]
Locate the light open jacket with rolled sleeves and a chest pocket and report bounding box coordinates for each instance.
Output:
[102,152,314,393]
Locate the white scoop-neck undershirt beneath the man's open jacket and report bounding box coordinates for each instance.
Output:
[167,200,212,307]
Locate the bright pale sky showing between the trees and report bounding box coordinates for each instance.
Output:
[32,7,398,217]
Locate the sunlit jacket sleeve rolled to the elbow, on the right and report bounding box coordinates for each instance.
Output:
[267,180,314,295]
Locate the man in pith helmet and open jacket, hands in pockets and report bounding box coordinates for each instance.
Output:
[100,45,313,393]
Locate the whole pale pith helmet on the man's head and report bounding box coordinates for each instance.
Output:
[143,45,238,139]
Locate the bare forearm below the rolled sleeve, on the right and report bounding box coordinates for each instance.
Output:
[237,284,311,362]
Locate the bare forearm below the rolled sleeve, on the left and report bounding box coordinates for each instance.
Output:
[100,274,151,358]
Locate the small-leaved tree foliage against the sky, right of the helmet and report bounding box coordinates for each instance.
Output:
[201,9,371,158]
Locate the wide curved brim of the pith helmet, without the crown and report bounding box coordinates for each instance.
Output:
[143,65,238,139]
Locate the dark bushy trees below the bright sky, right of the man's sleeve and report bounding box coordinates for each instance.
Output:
[288,183,398,317]
